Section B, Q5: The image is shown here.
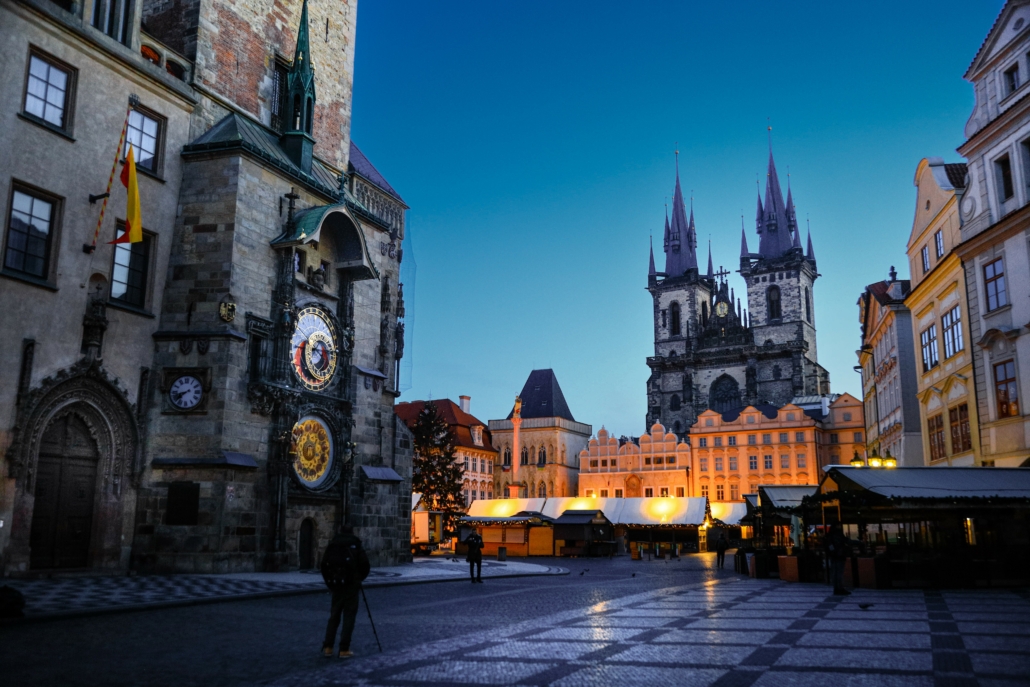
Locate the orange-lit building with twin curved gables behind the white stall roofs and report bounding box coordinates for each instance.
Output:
[579,423,697,499]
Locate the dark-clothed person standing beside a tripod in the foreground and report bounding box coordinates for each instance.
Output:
[321,525,371,658]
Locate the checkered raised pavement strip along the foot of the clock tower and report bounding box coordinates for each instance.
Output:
[3,557,567,619]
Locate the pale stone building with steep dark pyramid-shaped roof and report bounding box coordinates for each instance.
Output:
[489,370,592,499]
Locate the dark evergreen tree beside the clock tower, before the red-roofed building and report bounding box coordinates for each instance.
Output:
[411,401,465,523]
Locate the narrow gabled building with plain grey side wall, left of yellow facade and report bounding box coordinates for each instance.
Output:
[857,267,923,467]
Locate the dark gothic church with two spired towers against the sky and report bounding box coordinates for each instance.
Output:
[647,148,829,437]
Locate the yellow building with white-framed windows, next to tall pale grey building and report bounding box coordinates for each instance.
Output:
[904,158,982,466]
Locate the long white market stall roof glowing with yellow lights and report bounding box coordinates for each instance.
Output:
[482,496,707,525]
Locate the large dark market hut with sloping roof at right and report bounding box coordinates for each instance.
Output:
[802,466,1030,587]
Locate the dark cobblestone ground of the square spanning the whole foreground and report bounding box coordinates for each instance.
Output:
[0,554,1030,687]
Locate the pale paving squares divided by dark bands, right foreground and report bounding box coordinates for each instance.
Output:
[274,579,1030,687]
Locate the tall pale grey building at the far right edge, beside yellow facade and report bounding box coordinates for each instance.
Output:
[955,0,1030,468]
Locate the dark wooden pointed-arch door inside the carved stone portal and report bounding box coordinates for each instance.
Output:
[29,413,100,570]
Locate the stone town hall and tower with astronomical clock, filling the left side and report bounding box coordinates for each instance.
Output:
[0,0,411,574]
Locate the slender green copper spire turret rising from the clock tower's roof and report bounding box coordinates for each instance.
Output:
[280,0,315,174]
